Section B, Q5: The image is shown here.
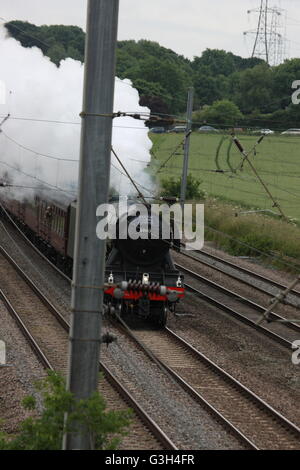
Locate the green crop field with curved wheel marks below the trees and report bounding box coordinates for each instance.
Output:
[150,132,300,220]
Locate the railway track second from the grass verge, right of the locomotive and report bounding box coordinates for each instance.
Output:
[175,264,300,350]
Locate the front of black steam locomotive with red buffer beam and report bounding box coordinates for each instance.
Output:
[105,202,184,326]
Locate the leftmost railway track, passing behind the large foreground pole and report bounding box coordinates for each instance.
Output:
[0,247,176,450]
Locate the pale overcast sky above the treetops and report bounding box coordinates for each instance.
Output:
[0,0,300,59]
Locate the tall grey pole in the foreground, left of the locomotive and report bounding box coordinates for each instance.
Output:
[63,0,119,449]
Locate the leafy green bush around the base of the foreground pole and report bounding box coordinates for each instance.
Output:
[0,371,131,450]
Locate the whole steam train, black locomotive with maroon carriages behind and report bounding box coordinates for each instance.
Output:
[0,192,185,327]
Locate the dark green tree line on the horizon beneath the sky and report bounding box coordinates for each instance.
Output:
[5,21,300,129]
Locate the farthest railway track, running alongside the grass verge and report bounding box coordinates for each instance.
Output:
[181,244,300,307]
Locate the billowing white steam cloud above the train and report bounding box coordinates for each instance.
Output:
[0,28,152,202]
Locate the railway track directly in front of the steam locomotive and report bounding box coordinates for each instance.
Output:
[2,218,299,449]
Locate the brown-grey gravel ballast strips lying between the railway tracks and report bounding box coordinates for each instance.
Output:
[0,220,300,449]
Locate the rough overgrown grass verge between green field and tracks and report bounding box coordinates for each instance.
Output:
[205,198,300,274]
